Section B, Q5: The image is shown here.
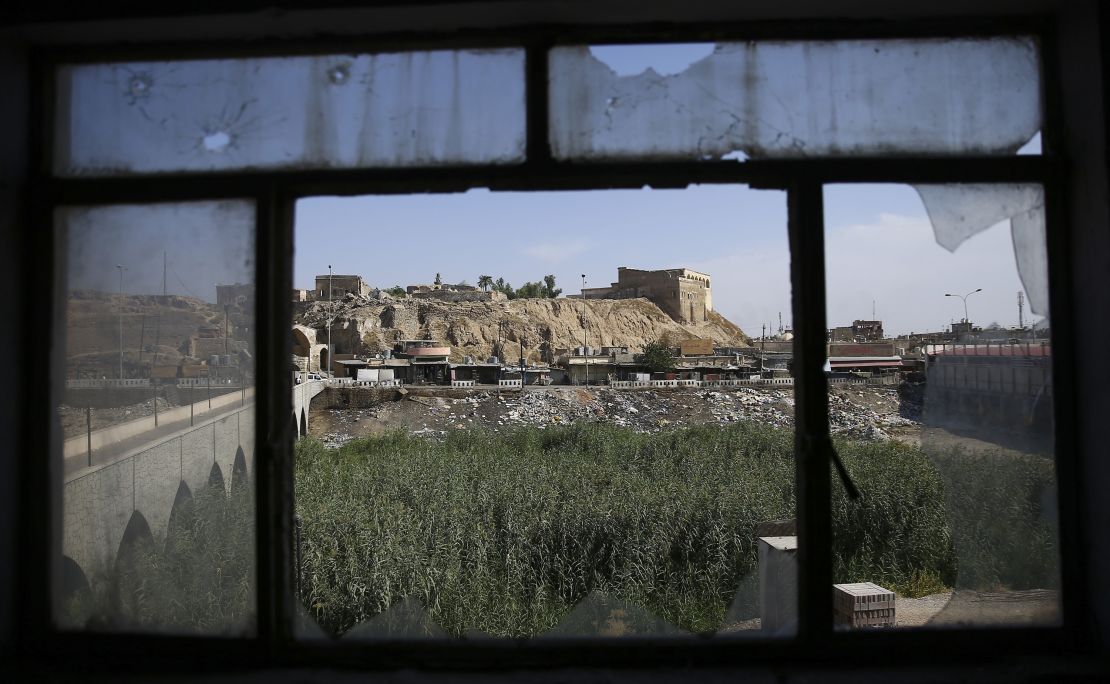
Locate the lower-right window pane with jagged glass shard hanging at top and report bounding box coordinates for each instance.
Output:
[825,184,1060,628]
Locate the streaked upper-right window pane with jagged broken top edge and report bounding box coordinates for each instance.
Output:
[549,38,1041,159]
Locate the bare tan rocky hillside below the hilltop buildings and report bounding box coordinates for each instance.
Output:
[294,293,749,361]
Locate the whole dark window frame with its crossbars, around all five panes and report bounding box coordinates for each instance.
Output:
[19,17,1093,670]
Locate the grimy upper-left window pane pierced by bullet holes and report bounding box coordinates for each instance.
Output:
[54,50,525,175]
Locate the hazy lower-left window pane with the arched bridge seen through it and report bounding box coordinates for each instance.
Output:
[52,201,255,635]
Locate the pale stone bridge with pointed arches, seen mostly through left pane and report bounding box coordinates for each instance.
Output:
[61,381,324,593]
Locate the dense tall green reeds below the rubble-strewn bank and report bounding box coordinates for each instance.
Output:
[296,423,1056,637]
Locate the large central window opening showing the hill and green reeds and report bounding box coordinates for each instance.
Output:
[291,187,797,640]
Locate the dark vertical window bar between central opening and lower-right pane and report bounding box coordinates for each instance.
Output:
[787,178,833,643]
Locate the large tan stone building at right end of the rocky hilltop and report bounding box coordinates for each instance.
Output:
[582,266,713,323]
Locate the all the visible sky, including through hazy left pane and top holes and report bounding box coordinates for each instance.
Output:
[70,44,1039,334]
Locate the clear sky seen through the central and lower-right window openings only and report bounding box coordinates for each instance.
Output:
[294,185,1029,334]
